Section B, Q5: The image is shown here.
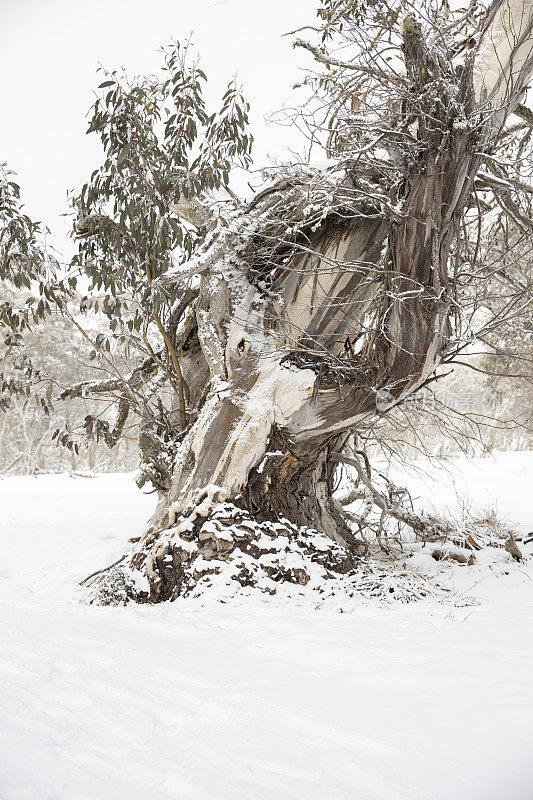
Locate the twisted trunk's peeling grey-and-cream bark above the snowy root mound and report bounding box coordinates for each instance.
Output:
[89,0,533,601]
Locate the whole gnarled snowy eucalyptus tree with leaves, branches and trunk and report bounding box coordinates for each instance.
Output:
[1,0,533,602]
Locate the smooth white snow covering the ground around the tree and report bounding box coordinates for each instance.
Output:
[0,452,533,800]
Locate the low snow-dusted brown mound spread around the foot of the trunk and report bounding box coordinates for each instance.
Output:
[88,503,453,606]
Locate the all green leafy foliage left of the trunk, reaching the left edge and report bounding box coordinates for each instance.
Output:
[0,43,252,456]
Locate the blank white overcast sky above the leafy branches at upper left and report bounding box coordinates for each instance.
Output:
[0,0,318,252]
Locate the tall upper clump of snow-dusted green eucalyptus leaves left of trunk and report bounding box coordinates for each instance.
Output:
[72,44,252,320]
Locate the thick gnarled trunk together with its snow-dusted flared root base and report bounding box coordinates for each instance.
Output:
[89,2,532,602]
